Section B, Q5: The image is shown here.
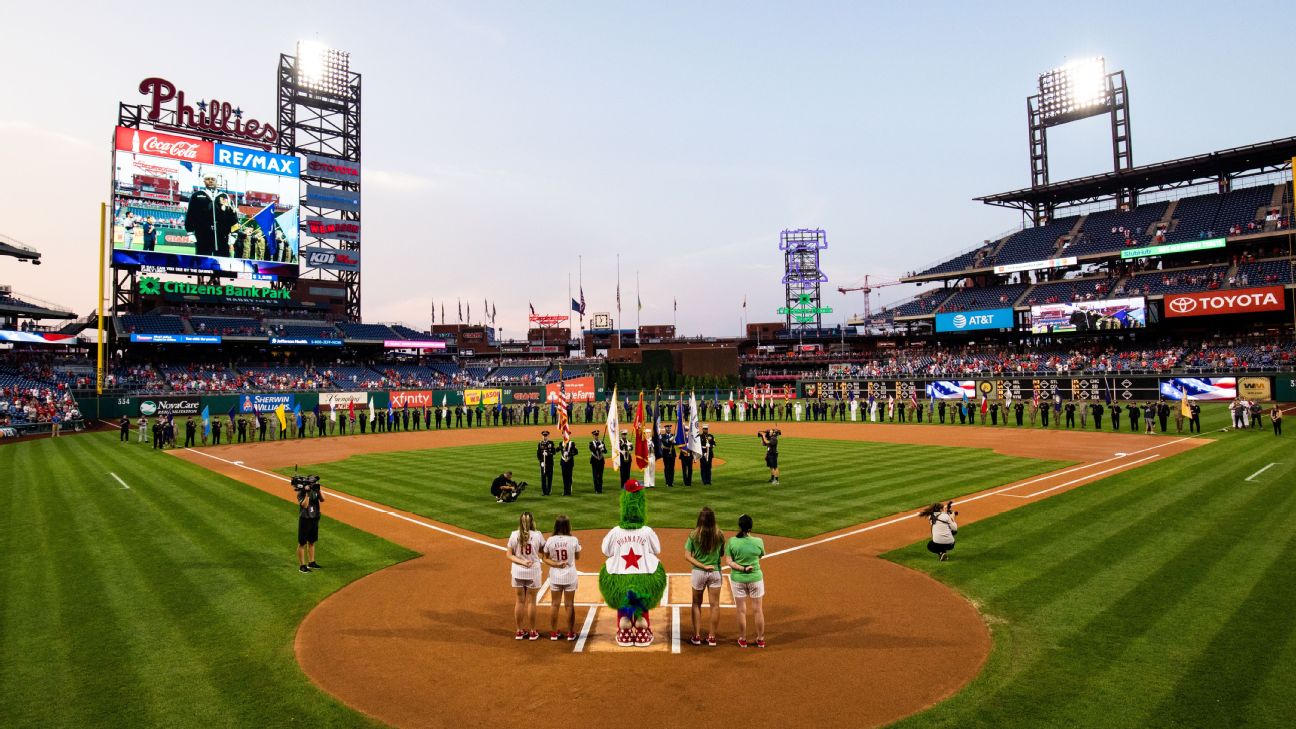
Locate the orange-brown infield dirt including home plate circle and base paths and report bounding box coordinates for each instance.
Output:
[175,423,1208,728]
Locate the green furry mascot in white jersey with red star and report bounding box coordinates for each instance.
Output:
[599,479,666,646]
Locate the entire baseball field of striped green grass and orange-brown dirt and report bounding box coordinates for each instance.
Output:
[0,406,1296,726]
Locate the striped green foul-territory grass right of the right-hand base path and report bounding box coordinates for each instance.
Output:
[886,410,1296,729]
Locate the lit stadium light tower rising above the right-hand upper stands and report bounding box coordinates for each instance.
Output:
[1026,56,1138,224]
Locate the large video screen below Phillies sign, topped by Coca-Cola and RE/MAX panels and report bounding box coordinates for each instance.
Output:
[113,127,301,279]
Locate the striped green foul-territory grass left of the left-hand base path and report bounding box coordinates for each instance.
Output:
[0,433,413,728]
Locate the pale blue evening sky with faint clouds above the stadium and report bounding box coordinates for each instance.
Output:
[0,0,1296,336]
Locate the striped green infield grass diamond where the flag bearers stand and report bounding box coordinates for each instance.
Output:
[283,435,1068,538]
